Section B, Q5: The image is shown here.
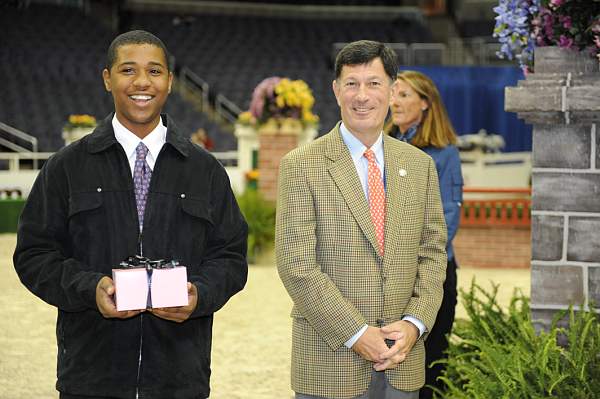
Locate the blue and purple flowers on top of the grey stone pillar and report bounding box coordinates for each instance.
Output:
[494,0,600,72]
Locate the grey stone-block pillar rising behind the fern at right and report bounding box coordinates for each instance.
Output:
[505,47,600,326]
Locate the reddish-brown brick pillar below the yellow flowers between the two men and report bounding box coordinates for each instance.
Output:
[258,131,298,201]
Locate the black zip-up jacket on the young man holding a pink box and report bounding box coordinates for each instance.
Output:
[14,115,248,399]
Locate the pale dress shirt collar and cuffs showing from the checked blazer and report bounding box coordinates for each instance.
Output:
[340,123,426,348]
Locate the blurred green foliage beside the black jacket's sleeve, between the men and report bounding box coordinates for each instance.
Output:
[237,189,275,261]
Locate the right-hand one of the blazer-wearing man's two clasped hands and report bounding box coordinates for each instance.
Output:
[375,320,419,371]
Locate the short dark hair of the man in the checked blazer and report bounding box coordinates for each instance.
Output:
[335,40,398,80]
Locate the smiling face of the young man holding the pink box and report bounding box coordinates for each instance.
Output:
[102,44,173,138]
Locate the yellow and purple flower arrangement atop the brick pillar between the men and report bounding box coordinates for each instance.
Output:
[238,76,319,127]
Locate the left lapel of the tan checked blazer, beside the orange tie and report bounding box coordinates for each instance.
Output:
[325,123,379,254]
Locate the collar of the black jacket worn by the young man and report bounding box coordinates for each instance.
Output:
[88,113,189,157]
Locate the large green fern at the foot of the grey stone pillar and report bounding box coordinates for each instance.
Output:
[436,282,600,399]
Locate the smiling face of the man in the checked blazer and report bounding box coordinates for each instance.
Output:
[333,58,391,147]
